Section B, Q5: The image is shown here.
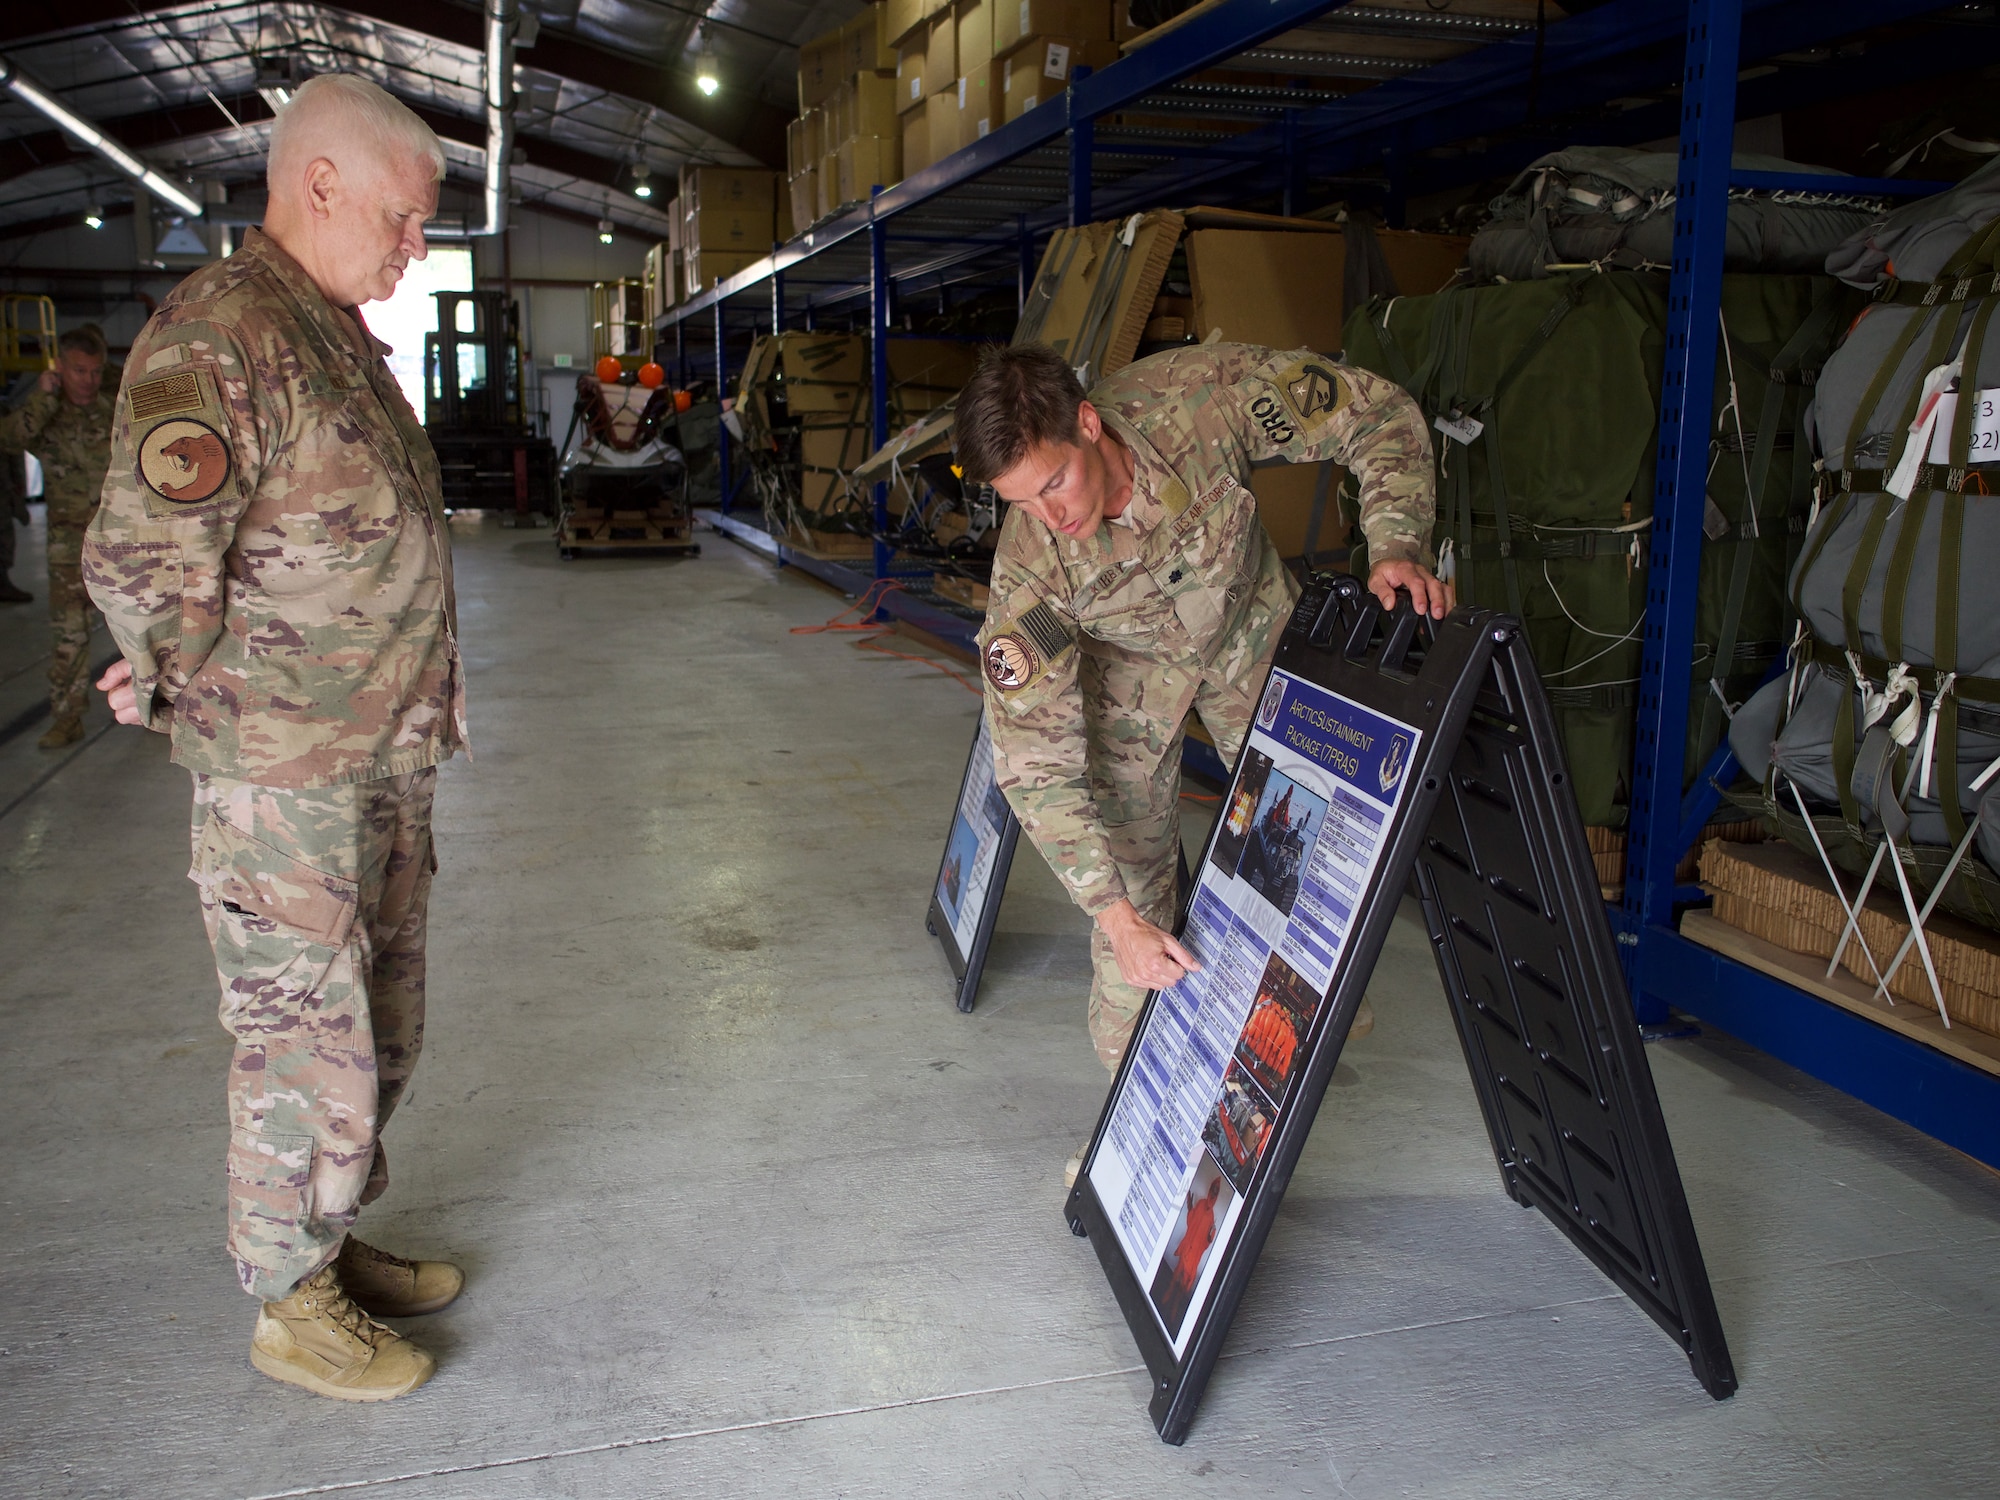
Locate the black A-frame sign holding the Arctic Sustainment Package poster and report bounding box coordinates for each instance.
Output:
[1066,574,1736,1442]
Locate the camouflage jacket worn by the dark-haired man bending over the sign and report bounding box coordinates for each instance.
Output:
[980,344,1436,916]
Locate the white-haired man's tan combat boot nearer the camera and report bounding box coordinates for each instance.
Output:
[250,1266,438,1402]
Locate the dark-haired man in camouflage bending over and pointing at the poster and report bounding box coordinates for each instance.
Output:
[956,344,1446,1104]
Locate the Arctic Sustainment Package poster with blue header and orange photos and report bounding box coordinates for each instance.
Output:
[1090,672,1422,1358]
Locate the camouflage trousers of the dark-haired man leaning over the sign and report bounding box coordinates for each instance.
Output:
[1078,638,1278,1072]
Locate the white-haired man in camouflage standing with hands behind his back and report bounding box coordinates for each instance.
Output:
[84,74,466,1400]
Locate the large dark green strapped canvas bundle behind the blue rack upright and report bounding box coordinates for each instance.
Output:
[1346,266,1860,828]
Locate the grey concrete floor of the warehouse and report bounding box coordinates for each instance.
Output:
[0,524,2000,1500]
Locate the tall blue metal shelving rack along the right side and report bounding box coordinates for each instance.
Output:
[660,0,2000,1166]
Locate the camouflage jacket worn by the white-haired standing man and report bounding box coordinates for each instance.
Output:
[84,230,466,786]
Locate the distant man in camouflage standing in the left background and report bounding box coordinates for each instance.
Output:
[0,322,114,750]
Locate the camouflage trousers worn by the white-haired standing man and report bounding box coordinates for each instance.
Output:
[190,766,438,1300]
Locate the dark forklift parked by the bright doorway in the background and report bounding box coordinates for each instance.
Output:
[424,292,558,526]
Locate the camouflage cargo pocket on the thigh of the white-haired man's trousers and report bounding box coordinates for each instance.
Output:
[188,812,360,1040]
